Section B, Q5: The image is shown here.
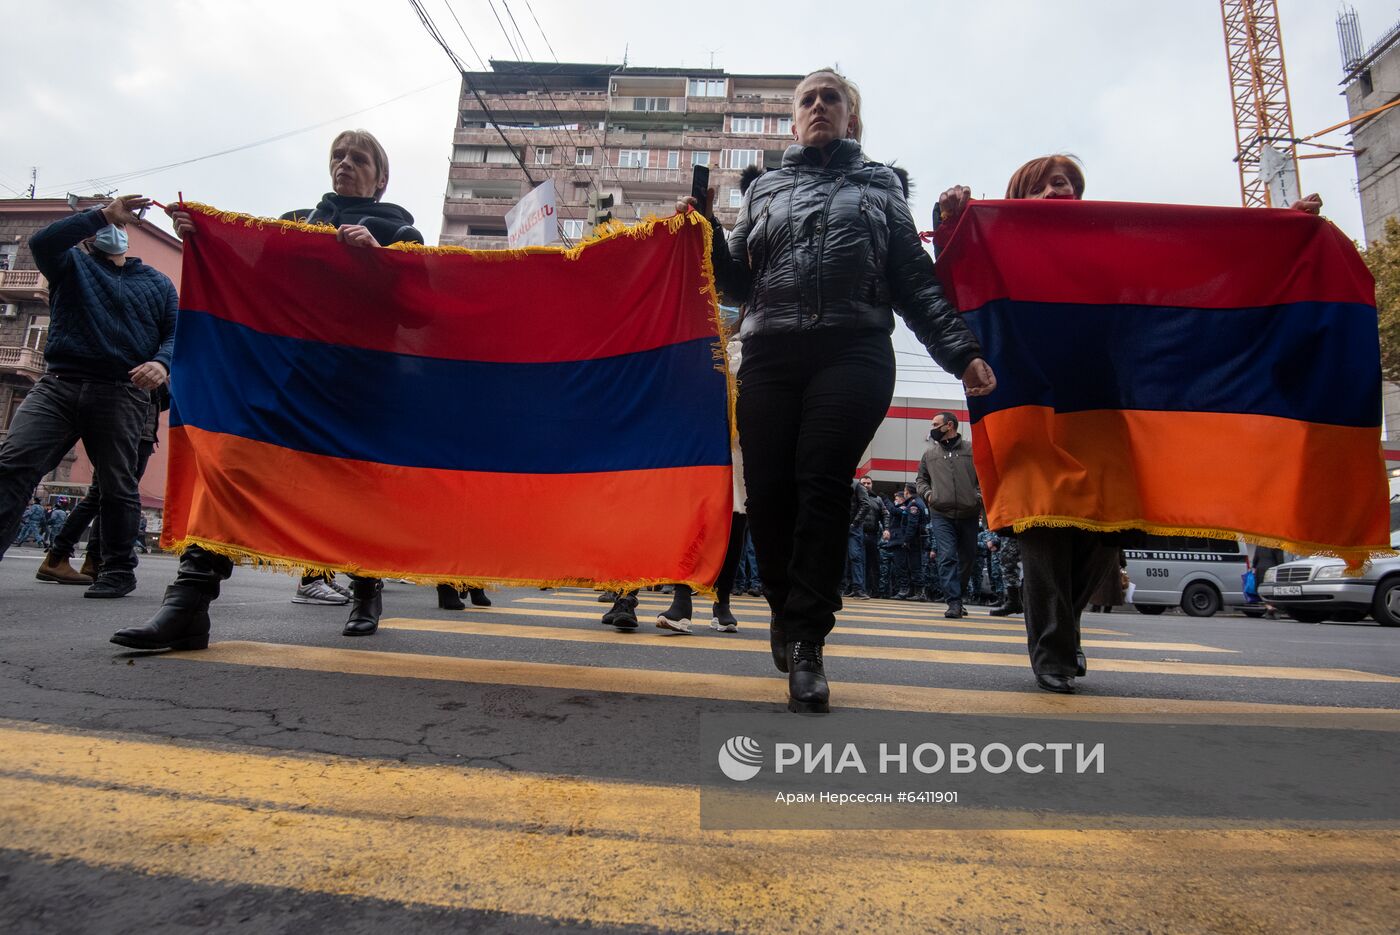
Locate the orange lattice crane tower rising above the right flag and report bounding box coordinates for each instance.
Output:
[1221,0,1298,207]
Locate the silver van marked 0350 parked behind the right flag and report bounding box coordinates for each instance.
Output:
[1123,536,1264,617]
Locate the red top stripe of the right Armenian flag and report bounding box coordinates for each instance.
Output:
[938,199,1375,312]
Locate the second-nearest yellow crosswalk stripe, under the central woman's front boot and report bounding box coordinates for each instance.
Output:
[158,641,1396,729]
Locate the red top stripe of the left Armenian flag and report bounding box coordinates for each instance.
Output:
[181,213,718,363]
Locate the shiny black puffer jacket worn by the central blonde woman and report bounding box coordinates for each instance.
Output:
[713,140,981,377]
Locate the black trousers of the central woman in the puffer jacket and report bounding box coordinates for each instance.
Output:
[738,329,895,642]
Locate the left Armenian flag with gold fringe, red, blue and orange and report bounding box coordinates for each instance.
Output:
[161,206,734,591]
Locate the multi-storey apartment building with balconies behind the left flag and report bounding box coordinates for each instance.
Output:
[440,62,802,249]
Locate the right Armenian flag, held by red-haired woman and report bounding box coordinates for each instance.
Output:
[938,200,1389,567]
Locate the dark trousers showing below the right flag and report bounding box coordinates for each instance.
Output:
[1016,526,1119,676]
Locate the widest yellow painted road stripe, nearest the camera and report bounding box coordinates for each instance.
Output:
[0,722,1400,935]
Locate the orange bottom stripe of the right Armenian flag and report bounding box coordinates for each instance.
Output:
[973,406,1389,557]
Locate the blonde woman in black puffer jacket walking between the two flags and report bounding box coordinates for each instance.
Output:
[682,69,995,711]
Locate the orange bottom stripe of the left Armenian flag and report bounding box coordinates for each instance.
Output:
[161,426,732,591]
